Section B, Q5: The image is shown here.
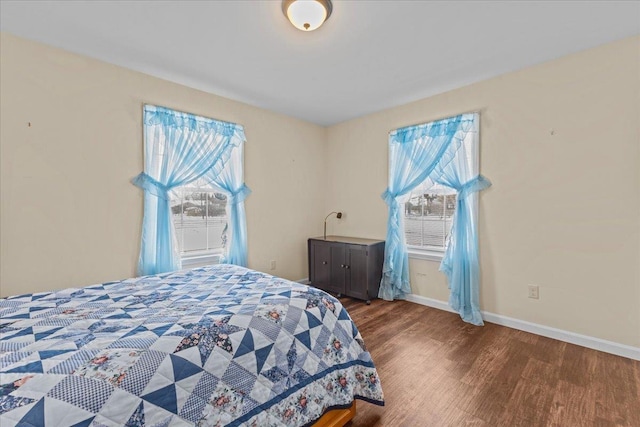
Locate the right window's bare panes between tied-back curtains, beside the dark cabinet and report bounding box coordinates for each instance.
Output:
[404,124,478,260]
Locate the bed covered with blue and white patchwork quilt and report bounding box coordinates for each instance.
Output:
[0,265,384,427]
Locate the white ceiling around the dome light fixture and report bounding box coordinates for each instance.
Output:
[0,0,640,125]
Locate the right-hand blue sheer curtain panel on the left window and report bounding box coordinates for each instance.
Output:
[206,145,251,267]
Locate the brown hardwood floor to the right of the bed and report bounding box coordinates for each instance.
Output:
[341,298,640,427]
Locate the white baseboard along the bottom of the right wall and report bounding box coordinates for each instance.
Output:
[406,294,640,360]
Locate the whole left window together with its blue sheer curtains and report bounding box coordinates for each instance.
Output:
[131,105,251,276]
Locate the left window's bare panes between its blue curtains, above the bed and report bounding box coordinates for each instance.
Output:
[171,179,227,266]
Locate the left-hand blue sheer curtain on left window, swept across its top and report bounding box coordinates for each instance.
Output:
[132,105,245,275]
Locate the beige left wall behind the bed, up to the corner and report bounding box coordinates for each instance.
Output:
[0,33,326,296]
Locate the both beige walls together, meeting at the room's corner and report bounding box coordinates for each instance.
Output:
[0,34,640,346]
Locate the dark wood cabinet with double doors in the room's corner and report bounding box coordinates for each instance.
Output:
[308,236,384,304]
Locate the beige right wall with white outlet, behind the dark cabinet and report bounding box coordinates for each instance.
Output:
[327,37,640,346]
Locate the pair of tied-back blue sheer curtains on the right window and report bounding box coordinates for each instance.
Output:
[379,114,490,324]
